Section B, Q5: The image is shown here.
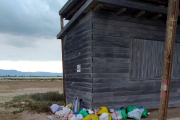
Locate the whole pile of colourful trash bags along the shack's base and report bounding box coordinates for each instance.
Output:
[48,101,150,120]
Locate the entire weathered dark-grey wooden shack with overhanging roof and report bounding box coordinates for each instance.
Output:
[57,0,180,109]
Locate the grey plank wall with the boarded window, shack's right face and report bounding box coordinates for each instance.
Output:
[91,12,180,109]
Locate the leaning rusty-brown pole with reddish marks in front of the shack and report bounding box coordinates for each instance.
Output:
[159,0,179,120]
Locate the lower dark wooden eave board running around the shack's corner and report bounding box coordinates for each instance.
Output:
[57,0,180,39]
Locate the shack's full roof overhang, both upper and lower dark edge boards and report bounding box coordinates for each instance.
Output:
[57,0,180,39]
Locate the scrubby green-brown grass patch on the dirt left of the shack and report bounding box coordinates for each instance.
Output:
[4,92,63,114]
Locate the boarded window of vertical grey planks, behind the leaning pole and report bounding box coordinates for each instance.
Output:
[131,39,180,80]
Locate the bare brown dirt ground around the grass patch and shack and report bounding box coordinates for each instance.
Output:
[0,81,180,120]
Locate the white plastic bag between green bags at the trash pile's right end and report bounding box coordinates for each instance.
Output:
[128,108,144,120]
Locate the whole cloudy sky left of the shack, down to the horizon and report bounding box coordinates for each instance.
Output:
[0,0,67,73]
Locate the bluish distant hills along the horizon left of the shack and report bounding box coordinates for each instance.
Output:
[0,69,62,76]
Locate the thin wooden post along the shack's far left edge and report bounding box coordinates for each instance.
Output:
[61,15,66,106]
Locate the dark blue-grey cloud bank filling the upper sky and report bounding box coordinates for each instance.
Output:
[0,0,67,37]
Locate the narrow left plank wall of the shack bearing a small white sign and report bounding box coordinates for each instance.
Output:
[64,12,92,108]
